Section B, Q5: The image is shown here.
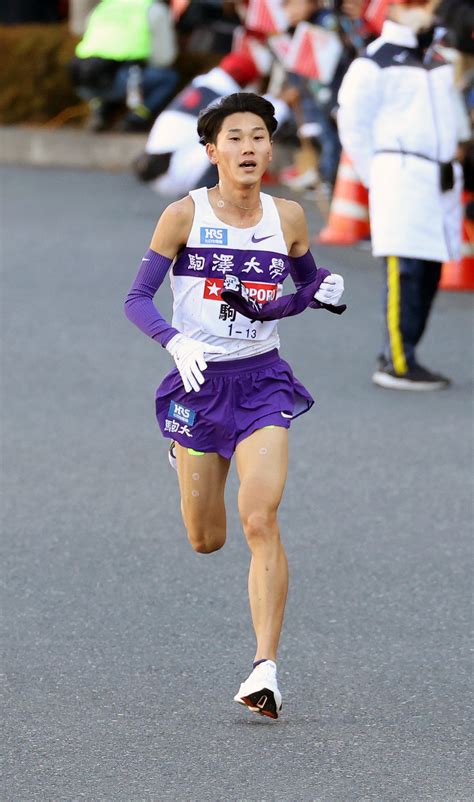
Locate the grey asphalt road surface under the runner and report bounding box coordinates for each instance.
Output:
[0,168,474,802]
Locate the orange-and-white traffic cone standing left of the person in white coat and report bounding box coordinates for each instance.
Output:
[316,153,370,245]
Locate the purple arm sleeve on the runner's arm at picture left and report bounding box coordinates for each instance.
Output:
[125,249,179,347]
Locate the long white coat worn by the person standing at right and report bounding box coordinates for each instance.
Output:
[338,21,462,262]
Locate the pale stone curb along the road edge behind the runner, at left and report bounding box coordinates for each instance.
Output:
[0,126,148,171]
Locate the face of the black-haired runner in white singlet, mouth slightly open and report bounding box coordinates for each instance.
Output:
[207,111,272,186]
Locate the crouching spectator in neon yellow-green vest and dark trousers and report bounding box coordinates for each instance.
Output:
[70,0,179,131]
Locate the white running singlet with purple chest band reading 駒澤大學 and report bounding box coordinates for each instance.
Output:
[170,187,290,361]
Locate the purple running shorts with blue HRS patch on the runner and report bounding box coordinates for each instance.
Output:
[156,350,314,459]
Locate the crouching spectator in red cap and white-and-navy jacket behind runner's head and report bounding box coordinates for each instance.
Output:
[135,53,259,196]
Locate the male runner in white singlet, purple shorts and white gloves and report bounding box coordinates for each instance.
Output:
[125,93,343,718]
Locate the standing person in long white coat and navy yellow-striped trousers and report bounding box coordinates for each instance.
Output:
[338,0,462,390]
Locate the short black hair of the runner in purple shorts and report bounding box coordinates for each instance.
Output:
[198,92,278,145]
